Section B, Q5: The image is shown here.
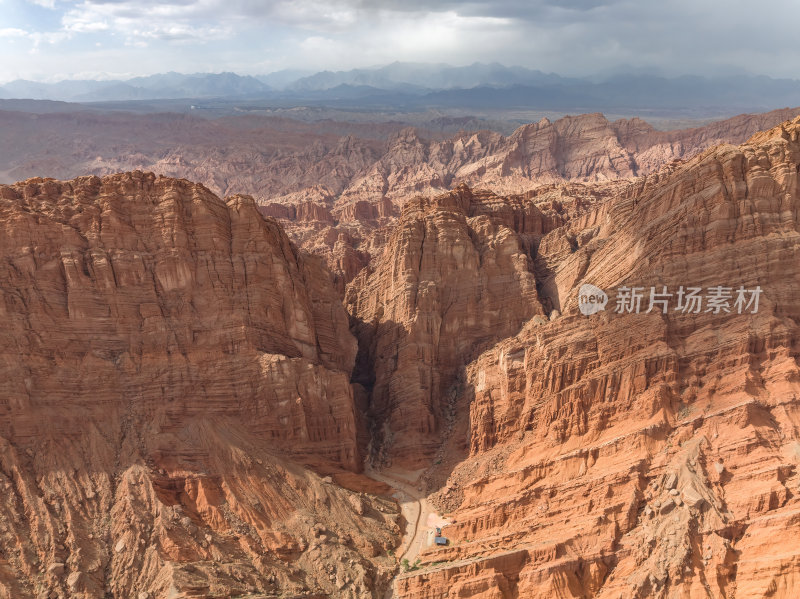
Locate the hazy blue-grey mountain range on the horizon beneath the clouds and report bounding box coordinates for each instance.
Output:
[0,62,800,112]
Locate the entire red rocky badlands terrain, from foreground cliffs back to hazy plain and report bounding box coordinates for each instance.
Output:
[0,109,800,599]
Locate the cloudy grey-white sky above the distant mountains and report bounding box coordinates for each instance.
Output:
[0,0,800,82]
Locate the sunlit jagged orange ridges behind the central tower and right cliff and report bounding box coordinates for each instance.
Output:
[264,109,798,289]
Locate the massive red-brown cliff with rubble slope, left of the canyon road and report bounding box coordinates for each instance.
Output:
[0,173,397,598]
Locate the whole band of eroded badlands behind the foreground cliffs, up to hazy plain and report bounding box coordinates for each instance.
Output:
[0,108,798,291]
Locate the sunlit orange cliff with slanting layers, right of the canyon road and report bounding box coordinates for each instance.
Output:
[399,119,800,597]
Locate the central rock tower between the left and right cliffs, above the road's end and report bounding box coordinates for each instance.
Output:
[345,186,557,466]
